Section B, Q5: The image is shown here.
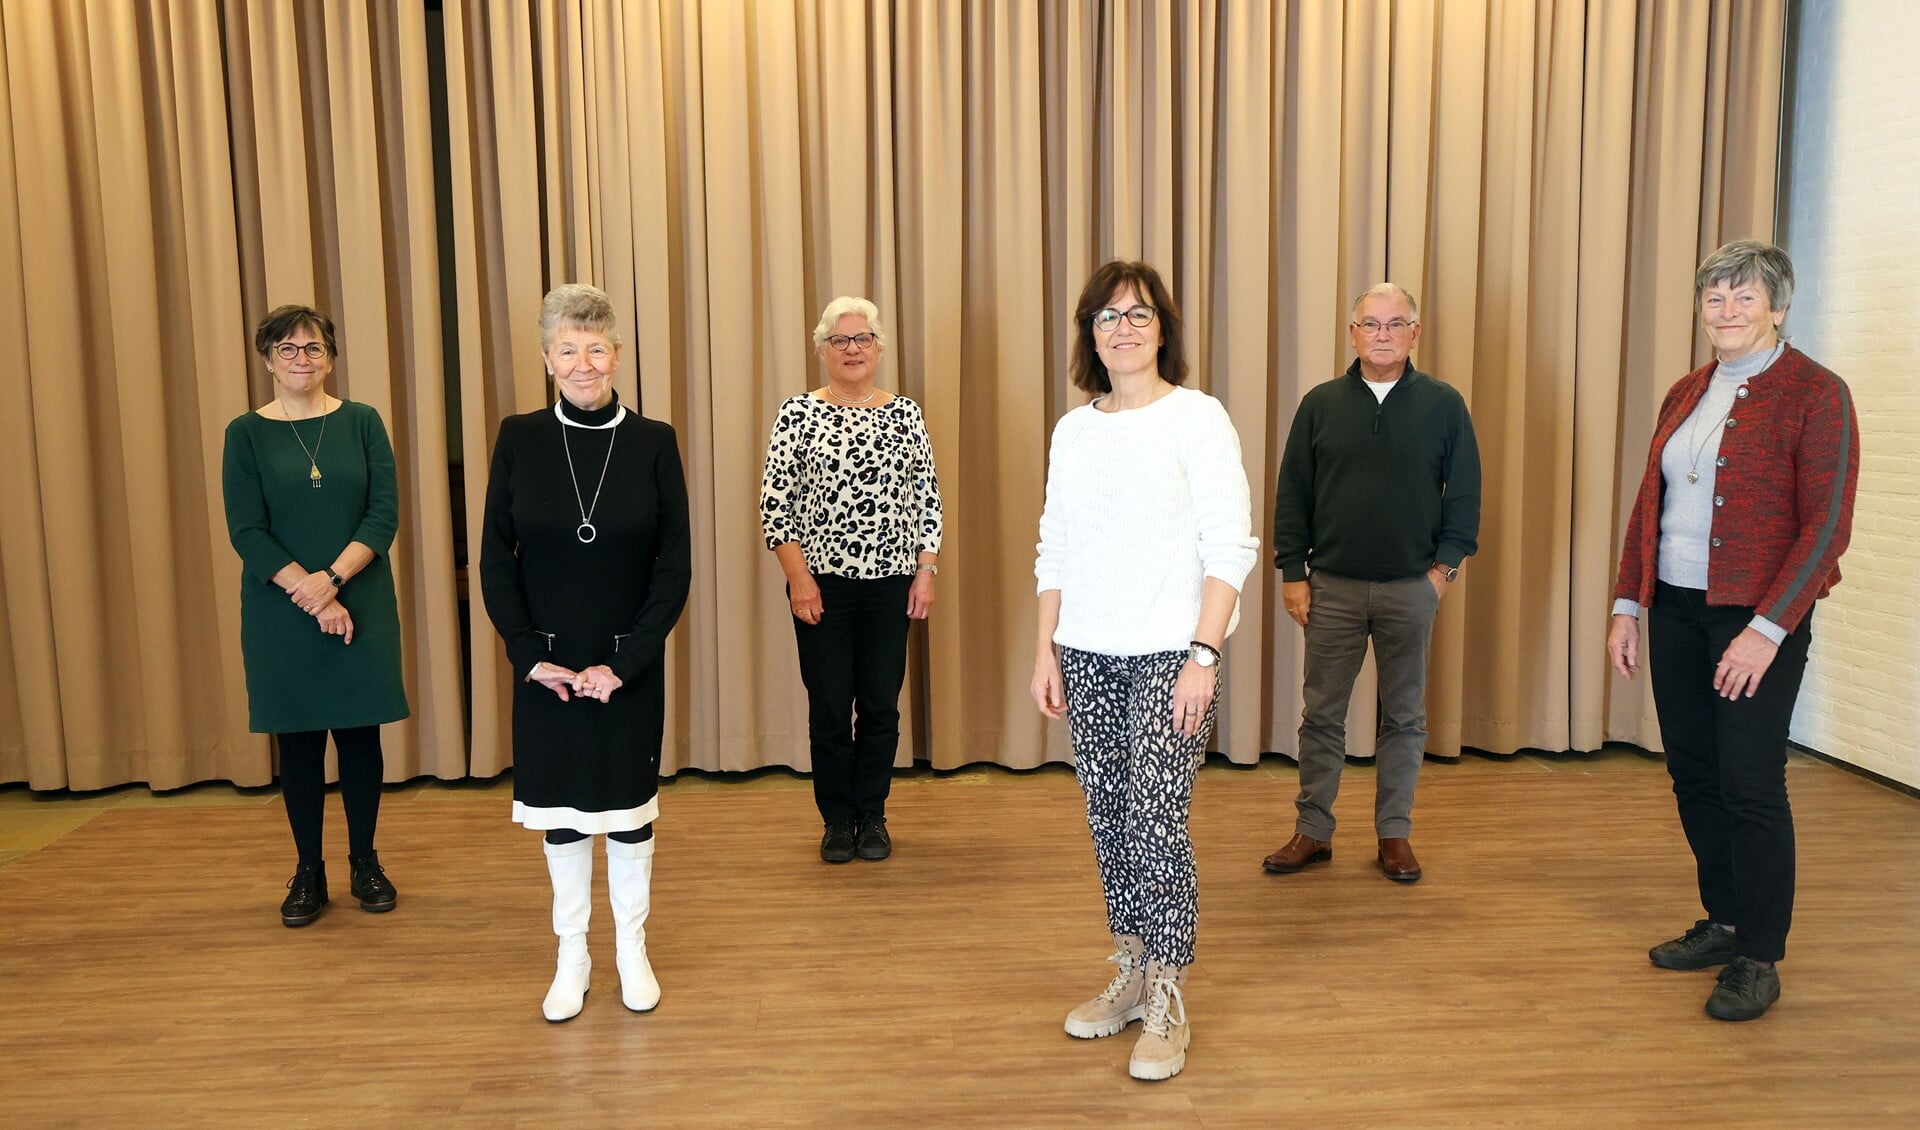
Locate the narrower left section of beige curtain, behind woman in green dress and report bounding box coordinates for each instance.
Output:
[0,0,467,789]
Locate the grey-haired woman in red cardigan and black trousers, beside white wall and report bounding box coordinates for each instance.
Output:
[1607,240,1860,1021]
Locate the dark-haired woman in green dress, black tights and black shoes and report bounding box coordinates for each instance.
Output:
[223,305,407,927]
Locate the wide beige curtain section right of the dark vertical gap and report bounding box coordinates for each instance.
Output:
[445,0,1784,769]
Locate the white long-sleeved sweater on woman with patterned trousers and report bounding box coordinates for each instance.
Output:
[1033,388,1260,656]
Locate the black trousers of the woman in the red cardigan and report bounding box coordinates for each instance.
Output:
[1647,581,1812,961]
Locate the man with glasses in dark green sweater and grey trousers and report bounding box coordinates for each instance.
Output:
[1263,282,1480,883]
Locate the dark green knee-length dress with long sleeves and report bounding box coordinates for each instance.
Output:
[221,401,407,733]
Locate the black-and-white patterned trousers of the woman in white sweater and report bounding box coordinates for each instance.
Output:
[1060,648,1217,967]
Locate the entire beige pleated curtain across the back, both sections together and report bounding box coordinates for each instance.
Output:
[0,0,1786,787]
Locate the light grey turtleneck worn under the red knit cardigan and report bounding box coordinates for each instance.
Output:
[1613,341,1788,643]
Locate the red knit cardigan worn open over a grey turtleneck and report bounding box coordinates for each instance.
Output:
[1613,345,1860,631]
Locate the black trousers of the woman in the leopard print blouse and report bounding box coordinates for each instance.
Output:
[793,574,914,823]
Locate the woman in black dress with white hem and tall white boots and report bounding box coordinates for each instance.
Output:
[480,284,691,1021]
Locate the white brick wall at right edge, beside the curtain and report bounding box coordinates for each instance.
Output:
[1784,0,1920,785]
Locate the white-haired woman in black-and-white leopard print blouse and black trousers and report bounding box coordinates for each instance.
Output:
[760,297,941,863]
